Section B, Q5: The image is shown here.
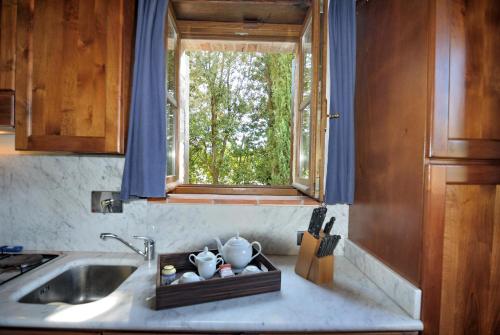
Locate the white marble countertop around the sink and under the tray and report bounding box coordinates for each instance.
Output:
[0,252,422,332]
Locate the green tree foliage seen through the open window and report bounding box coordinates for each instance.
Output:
[189,51,293,185]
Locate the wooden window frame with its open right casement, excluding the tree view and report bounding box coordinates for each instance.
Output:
[166,0,328,201]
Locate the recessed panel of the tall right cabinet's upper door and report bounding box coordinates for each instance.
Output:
[449,0,500,140]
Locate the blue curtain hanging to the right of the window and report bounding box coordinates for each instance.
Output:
[325,0,356,204]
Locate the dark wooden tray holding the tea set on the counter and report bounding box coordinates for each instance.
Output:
[155,249,281,309]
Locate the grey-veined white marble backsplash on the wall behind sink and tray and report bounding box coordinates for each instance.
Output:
[0,135,348,254]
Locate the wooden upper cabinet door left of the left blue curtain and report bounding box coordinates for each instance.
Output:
[15,0,134,153]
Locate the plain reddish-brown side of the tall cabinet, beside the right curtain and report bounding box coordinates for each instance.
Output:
[349,0,429,285]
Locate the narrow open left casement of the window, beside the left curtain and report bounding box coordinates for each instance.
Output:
[165,3,181,185]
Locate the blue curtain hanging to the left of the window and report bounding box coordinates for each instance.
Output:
[121,0,168,200]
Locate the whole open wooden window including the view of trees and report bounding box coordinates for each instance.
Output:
[166,0,326,198]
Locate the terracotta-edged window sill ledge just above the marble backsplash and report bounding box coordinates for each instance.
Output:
[148,194,320,206]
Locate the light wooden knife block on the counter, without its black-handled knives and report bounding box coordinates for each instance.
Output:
[295,232,334,284]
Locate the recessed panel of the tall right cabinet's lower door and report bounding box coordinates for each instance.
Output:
[440,185,500,335]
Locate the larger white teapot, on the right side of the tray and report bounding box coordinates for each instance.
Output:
[215,234,262,272]
